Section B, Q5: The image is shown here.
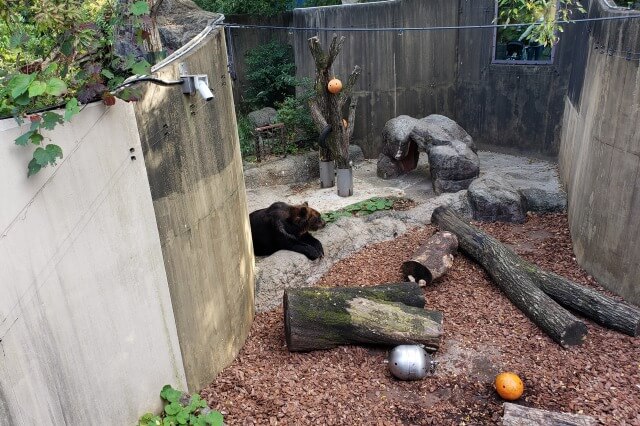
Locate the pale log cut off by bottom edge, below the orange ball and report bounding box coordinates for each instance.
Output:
[502,402,598,426]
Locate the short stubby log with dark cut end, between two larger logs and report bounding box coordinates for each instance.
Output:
[402,232,458,284]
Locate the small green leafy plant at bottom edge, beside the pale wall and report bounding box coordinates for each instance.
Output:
[138,385,224,426]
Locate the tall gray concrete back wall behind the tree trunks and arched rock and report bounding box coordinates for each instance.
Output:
[227,0,577,158]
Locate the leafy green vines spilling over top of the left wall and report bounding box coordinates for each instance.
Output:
[0,0,150,176]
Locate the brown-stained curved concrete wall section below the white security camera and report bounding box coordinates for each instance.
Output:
[136,28,254,390]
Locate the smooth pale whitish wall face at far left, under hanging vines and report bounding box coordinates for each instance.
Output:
[0,102,186,426]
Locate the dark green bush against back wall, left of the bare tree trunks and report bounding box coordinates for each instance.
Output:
[244,40,296,109]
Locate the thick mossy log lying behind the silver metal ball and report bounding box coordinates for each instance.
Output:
[283,283,442,352]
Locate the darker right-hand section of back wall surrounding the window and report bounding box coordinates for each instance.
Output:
[452,0,581,157]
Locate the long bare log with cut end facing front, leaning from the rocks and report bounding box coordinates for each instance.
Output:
[431,207,587,347]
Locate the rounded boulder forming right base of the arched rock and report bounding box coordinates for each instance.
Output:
[428,140,480,194]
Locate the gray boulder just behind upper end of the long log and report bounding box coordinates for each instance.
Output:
[467,173,526,223]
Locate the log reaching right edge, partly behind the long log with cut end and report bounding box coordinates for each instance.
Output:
[434,208,640,337]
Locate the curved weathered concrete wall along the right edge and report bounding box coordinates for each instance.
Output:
[559,0,640,305]
